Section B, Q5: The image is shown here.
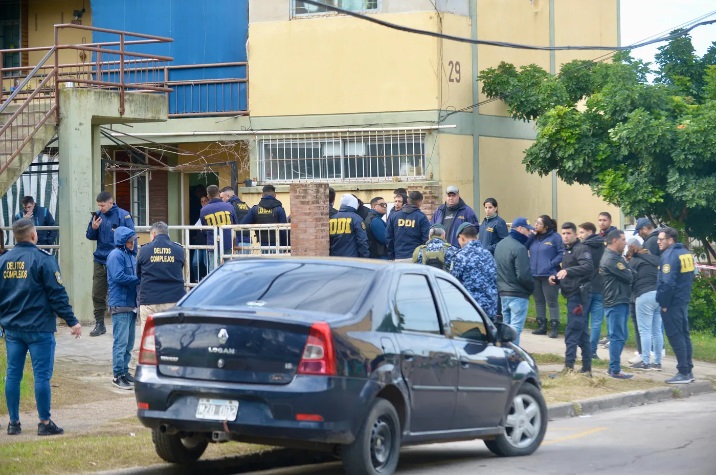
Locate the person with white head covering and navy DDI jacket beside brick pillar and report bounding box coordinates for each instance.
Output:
[328,193,369,258]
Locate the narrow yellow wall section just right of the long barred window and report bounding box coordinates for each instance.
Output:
[438,134,479,208]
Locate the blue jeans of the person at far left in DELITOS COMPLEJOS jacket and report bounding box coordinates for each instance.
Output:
[5,330,55,422]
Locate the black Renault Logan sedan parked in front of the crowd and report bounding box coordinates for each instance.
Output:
[135,258,547,474]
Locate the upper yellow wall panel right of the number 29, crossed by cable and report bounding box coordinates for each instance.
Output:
[478,0,552,117]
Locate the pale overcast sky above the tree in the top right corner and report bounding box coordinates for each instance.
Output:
[621,0,716,63]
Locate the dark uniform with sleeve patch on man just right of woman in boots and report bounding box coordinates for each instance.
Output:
[559,241,594,372]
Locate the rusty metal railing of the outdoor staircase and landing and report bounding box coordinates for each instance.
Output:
[0,24,173,178]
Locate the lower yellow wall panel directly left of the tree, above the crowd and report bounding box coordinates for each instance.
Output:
[475,137,552,223]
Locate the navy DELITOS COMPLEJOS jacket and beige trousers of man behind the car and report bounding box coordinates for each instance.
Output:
[137,234,186,333]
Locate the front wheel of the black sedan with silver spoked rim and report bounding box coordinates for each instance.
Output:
[485,383,547,457]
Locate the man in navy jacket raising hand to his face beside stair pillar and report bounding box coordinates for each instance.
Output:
[86,191,134,336]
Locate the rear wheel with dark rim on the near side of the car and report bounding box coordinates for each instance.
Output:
[342,399,400,475]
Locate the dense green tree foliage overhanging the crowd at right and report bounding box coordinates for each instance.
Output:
[478,34,716,251]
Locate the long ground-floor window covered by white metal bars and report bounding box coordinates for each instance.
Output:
[259,133,425,182]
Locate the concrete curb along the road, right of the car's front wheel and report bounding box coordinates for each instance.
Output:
[547,381,714,420]
